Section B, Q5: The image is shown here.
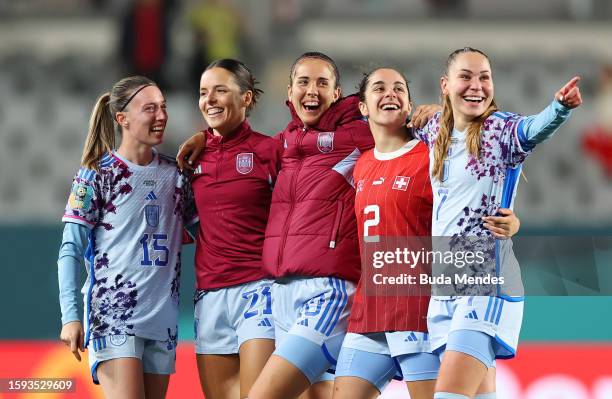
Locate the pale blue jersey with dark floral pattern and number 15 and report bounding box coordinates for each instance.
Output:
[62,152,196,345]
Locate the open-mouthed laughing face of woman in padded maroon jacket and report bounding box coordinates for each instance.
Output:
[287,58,340,126]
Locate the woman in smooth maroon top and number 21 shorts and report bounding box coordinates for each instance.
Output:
[192,59,282,399]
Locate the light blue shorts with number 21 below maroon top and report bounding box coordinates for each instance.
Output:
[194,280,274,355]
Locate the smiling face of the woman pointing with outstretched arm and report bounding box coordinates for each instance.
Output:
[440,52,494,130]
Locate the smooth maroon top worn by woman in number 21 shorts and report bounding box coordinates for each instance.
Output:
[192,121,282,289]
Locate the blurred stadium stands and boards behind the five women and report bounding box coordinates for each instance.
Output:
[0,0,612,399]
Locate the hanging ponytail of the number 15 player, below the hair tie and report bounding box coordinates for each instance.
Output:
[81,93,115,171]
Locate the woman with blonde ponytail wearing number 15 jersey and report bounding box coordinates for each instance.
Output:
[58,76,196,398]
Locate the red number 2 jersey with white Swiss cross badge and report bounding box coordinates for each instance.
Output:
[348,139,433,333]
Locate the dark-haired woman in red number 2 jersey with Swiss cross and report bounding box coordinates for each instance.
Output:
[334,68,439,399]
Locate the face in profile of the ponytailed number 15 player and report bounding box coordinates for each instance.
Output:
[117,86,168,147]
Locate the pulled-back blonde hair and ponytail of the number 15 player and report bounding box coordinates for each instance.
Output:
[81,76,156,171]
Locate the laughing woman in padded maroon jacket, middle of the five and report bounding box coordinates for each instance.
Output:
[249,53,374,398]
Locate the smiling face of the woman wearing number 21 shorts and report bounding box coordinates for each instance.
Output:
[198,67,253,136]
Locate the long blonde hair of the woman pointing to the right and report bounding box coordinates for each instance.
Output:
[433,47,497,181]
